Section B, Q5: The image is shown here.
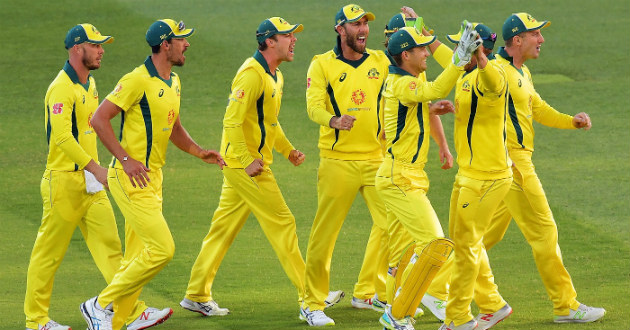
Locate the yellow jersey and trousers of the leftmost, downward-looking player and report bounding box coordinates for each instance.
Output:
[24,62,146,329]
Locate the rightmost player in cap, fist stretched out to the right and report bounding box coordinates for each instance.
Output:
[484,13,606,323]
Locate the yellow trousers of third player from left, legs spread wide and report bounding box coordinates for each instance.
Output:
[186,167,304,302]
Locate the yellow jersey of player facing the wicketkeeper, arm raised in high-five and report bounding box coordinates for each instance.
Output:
[455,58,512,180]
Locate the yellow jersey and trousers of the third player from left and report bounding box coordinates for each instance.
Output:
[186,51,304,302]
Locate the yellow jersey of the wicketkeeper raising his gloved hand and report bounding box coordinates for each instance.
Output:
[383,64,462,165]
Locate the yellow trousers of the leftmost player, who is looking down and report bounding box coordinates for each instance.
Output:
[24,170,146,329]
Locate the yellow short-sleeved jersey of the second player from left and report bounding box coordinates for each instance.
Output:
[107,56,181,169]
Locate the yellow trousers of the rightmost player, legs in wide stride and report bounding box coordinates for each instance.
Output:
[483,149,580,315]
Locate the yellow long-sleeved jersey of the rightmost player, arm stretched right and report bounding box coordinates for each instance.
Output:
[496,47,575,151]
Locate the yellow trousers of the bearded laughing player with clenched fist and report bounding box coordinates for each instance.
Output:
[304,158,387,310]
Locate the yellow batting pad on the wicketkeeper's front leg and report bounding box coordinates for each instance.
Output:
[392,238,454,319]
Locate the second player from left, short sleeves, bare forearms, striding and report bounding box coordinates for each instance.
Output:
[80,19,225,330]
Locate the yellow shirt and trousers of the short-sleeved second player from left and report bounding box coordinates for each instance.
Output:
[98,56,181,322]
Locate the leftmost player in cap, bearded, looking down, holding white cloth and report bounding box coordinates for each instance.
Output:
[24,23,172,330]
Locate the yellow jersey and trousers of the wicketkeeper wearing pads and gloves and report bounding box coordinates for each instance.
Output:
[375,54,461,302]
